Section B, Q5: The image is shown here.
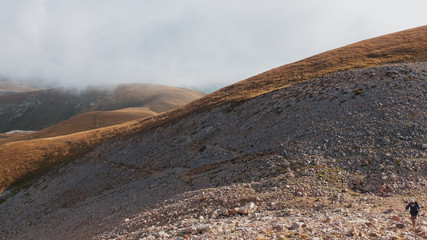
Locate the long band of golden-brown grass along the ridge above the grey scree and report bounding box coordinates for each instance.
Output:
[0,26,427,192]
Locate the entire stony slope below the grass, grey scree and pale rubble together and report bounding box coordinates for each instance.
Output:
[0,63,427,239]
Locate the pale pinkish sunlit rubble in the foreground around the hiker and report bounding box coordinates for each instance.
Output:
[96,180,427,240]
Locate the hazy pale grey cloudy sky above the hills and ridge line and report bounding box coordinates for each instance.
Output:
[0,0,427,90]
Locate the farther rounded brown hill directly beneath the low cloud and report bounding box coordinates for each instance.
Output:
[0,84,205,132]
